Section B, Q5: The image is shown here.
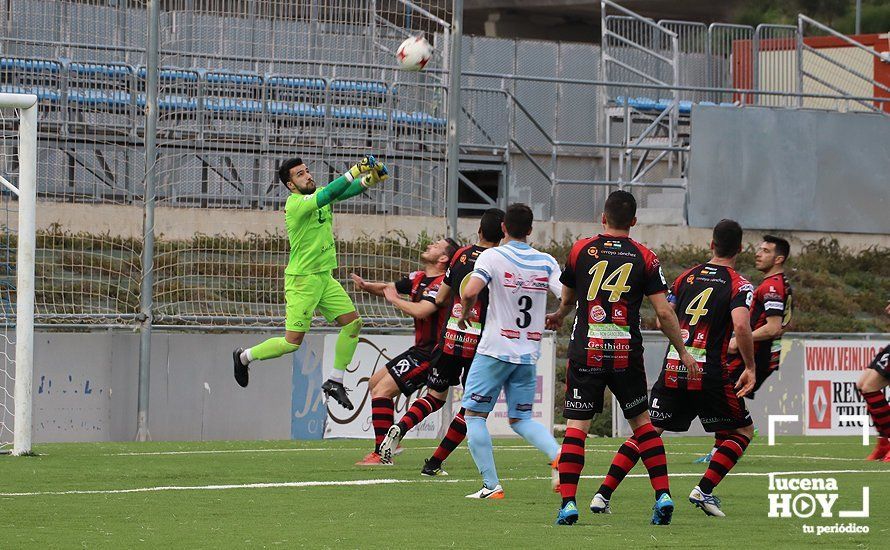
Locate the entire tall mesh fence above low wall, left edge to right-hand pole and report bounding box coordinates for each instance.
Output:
[0,0,451,336]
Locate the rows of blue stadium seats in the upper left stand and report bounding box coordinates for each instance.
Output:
[0,57,445,142]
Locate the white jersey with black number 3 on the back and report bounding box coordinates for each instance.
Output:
[472,241,562,364]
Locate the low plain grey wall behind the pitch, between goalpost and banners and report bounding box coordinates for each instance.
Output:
[33,331,294,443]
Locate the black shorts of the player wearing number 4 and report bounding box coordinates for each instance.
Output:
[649,377,753,432]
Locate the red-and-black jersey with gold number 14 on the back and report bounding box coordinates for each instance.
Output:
[559,235,667,369]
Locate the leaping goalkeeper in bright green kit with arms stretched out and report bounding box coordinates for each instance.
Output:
[232,156,389,410]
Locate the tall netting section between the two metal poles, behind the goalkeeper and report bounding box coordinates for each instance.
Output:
[151,0,451,326]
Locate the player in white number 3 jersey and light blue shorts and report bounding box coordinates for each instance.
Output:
[458,204,562,499]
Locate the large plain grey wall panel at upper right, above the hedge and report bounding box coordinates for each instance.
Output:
[687,106,890,235]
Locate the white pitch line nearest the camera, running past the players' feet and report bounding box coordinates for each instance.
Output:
[0,470,890,498]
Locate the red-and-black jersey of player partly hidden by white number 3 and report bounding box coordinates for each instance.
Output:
[439,244,488,358]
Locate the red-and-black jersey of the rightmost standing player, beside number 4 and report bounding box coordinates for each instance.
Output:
[730,273,792,370]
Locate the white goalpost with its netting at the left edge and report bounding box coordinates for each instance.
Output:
[0,93,37,454]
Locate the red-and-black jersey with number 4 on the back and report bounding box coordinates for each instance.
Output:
[661,263,754,390]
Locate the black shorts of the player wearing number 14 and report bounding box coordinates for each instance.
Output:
[562,357,648,420]
